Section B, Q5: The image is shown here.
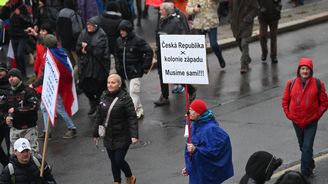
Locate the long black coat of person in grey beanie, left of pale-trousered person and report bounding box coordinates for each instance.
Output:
[76,20,110,83]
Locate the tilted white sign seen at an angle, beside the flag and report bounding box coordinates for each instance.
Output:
[41,50,59,126]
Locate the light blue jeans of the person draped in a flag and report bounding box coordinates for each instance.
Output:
[40,95,76,132]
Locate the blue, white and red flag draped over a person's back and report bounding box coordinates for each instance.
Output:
[49,48,79,116]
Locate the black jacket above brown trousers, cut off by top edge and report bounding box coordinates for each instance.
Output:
[258,0,282,22]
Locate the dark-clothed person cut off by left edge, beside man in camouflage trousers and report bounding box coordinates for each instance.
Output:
[0,63,11,167]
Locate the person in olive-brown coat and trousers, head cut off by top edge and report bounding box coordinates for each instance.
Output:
[230,0,258,74]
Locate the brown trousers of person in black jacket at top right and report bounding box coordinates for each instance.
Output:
[259,19,278,59]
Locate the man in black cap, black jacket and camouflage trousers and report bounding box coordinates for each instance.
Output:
[6,68,39,154]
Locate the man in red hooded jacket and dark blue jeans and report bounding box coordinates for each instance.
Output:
[282,58,328,177]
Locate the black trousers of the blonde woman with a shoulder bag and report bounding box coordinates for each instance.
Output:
[107,146,132,182]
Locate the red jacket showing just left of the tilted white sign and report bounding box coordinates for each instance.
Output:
[33,43,47,94]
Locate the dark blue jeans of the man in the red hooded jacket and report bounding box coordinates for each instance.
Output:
[293,121,318,176]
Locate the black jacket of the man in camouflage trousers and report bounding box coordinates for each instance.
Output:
[8,83,38,129]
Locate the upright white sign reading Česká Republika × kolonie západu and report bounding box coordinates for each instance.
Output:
[160,35,208,84]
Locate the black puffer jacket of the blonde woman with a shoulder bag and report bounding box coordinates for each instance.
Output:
[93,90,138,150]
